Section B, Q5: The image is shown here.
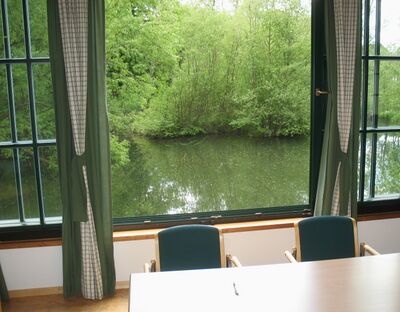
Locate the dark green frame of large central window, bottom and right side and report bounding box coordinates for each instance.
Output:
[109,0,327,230]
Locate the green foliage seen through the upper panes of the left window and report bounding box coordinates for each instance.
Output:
[0,0,55,157]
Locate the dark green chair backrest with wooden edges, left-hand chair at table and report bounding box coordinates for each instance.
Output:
[156,224,226,271]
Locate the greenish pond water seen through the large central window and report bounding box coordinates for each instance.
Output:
[112,136,310,217]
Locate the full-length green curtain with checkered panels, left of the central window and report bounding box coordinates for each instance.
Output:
[48,0,115,299]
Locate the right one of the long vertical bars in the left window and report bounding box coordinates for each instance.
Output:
[22,0,45,225]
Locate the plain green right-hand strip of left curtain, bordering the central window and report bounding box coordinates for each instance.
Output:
[86,0,115,295]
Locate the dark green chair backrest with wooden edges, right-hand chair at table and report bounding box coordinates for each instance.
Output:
[295,216,360,261]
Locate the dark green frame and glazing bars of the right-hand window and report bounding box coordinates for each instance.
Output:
[358,0,400,214]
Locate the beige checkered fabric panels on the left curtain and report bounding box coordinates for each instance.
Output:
[58,0,103,299]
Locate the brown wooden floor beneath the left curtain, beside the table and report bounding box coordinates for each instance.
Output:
[3,289,128,312]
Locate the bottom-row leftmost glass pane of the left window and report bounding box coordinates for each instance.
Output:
[0,149,19,219]
